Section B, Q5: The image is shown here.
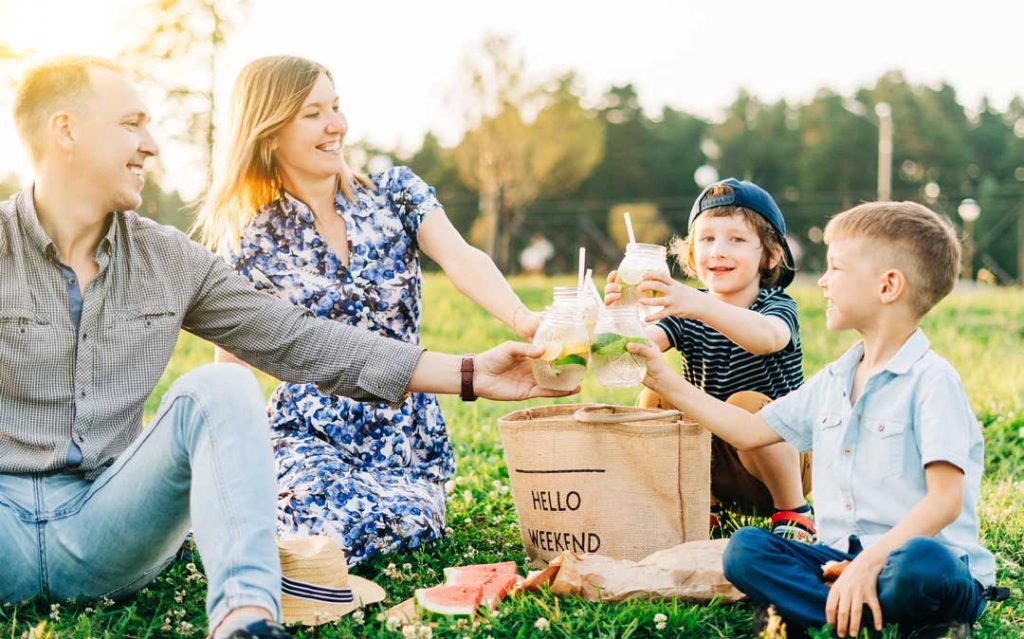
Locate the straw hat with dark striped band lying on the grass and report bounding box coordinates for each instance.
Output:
[278,537,386,626]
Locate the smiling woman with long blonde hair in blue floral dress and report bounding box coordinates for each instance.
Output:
[197,56,541,565]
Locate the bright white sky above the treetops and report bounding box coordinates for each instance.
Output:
[0,0,1024,195]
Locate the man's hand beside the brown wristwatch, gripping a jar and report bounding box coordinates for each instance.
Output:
[473,342,580,401]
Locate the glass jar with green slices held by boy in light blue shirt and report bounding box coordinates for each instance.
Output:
[590,305,649,387]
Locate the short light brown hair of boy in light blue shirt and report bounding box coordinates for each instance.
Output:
[824,202,961,317]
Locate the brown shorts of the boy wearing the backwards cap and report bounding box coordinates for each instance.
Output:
[636,388,811,515]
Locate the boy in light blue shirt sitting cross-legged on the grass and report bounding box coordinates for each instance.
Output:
[633,202,995,637]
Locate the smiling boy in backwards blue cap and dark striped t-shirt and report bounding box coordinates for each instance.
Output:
[605,178,815,543]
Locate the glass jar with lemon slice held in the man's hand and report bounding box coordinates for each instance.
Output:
[530,303,590,390]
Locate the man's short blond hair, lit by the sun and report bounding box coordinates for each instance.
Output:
[14,55,124,163]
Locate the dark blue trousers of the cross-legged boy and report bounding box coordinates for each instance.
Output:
[722,527,986,630]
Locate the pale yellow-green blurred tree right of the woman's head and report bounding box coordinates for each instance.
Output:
[455,36,604,270]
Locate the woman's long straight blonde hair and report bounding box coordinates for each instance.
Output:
[191,55,372,251]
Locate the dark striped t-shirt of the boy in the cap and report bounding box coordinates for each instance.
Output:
[657,288,804,400]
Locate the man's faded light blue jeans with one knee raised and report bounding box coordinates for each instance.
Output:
[0,364,281,628]
